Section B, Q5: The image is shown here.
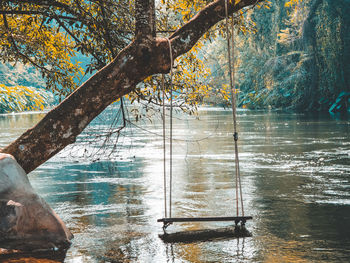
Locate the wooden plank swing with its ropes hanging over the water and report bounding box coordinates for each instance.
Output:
[157,0,252,231]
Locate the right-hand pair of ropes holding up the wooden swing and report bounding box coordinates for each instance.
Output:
[225,0,244,219]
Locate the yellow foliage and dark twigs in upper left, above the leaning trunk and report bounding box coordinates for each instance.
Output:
[0,0,133,96]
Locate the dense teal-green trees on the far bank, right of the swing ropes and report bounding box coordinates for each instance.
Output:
[232,0,350,111]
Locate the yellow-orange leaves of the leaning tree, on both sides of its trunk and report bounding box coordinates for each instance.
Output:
[0,0,268,112]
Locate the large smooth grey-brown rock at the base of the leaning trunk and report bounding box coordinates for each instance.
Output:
[0,153,73,251]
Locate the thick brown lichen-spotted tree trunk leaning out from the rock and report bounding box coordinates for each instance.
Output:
[1,0,261,173]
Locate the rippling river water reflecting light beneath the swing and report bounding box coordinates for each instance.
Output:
[0,107,350,262]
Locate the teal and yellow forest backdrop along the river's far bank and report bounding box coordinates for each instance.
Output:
[0,0,350,113]
